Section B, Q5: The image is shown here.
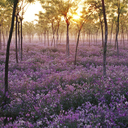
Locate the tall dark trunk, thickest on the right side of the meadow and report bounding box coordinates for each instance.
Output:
[101,0,108,77]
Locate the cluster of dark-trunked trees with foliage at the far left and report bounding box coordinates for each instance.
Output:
[0,0,34,105]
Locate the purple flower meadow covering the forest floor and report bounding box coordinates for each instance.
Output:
[0,44,128,128]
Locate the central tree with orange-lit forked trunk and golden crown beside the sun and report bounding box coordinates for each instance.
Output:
[40,0,79,56]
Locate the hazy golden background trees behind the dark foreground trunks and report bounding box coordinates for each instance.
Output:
[0,0,128,51]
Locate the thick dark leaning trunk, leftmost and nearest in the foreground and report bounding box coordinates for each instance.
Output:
[4,0,18,104]
